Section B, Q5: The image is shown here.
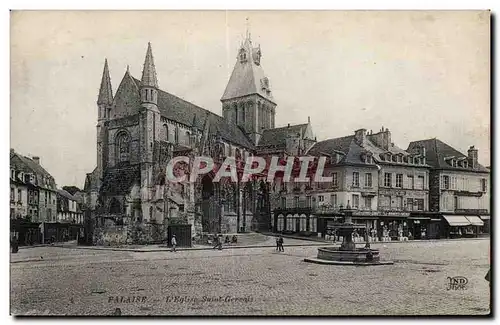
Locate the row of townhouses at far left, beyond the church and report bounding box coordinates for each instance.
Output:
[10,149,83,244]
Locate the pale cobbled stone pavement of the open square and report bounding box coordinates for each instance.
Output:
[11,240,490,315]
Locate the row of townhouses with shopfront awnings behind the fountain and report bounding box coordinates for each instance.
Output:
[273,128,490,239]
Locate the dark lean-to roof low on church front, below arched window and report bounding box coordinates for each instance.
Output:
[99,165,141,195]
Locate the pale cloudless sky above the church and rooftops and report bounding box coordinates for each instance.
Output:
[10,11,490,187]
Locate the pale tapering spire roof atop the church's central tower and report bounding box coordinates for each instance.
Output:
[221,37,274,102]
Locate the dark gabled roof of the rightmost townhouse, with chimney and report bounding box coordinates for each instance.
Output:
[407,138,490,173]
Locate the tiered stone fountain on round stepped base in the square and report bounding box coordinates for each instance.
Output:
[304,201,394,266]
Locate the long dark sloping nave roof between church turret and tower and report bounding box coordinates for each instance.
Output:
[134,78,253,149]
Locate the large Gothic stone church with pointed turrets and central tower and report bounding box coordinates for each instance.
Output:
[85,33,316,242]
